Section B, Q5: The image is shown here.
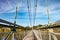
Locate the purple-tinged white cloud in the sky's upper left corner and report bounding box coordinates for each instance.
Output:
[0,1,15,13]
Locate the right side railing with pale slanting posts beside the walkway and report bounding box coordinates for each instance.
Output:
[40,29,60,40]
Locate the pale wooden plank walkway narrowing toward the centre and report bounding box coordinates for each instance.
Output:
[23,30,42,40]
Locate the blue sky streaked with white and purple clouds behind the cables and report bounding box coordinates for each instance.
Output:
[0,0,60,26]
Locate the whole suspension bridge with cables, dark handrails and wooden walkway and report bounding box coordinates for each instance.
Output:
[0,0,60,40]
